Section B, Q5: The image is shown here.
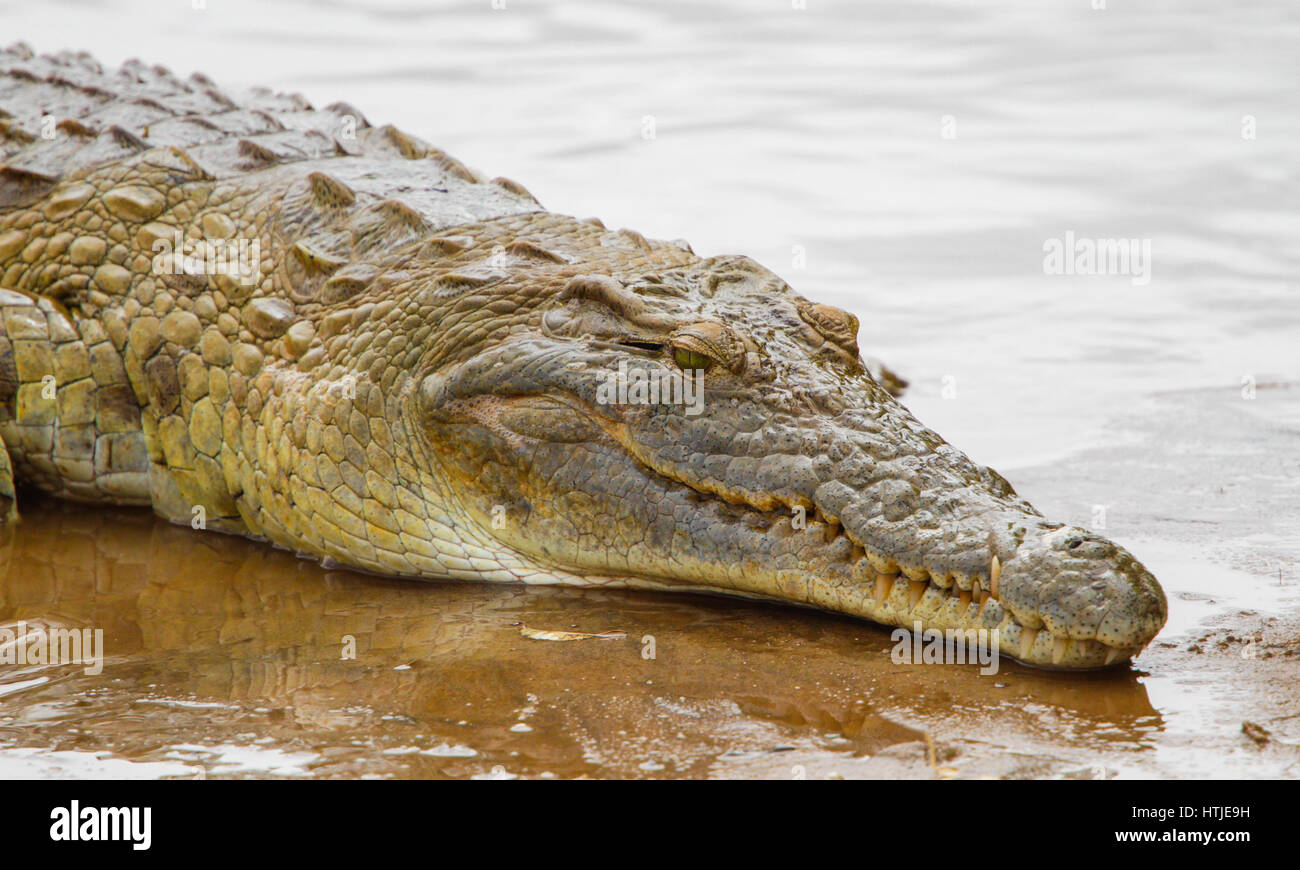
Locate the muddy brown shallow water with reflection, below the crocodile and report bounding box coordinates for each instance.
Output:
[0,502,1161,776]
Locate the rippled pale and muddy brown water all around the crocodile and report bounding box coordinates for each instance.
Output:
[0,0,1300,778]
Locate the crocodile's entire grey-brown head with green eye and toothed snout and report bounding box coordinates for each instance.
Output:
[413,247,1166,668]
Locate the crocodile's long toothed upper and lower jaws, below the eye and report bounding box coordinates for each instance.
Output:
[412,295,1166,670]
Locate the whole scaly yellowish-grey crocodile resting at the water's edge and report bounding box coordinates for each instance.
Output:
[0,44,1167,670]
